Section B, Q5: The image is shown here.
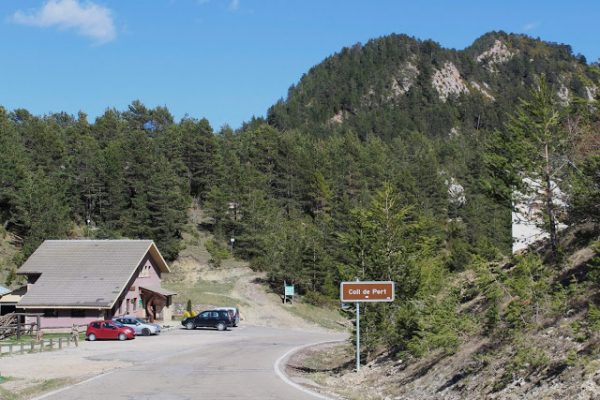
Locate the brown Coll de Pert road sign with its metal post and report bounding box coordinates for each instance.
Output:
[340,279,395,372]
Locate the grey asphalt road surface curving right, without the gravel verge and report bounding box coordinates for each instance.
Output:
[38,326,344,400]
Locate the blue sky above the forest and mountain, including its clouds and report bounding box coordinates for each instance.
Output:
[0,0,600,129]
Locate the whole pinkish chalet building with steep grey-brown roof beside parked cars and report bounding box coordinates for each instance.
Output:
[17,240,175,328]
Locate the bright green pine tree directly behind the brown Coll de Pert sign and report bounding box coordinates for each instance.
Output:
[339,184,441,354]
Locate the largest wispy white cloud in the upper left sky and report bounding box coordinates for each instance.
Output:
[12,0,117,43]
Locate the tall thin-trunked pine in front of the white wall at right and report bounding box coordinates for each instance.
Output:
[486,76,573,260]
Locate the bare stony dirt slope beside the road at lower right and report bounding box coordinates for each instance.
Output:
[288,232,600,400]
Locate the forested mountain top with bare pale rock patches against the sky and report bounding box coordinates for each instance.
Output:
[268,32,600,141]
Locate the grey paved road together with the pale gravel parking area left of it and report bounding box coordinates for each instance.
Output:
[0,326,344,400]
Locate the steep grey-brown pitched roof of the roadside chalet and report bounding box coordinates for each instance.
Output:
[18,240,169,308]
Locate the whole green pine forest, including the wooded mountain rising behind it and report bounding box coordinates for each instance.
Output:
[0,33,600,372]
